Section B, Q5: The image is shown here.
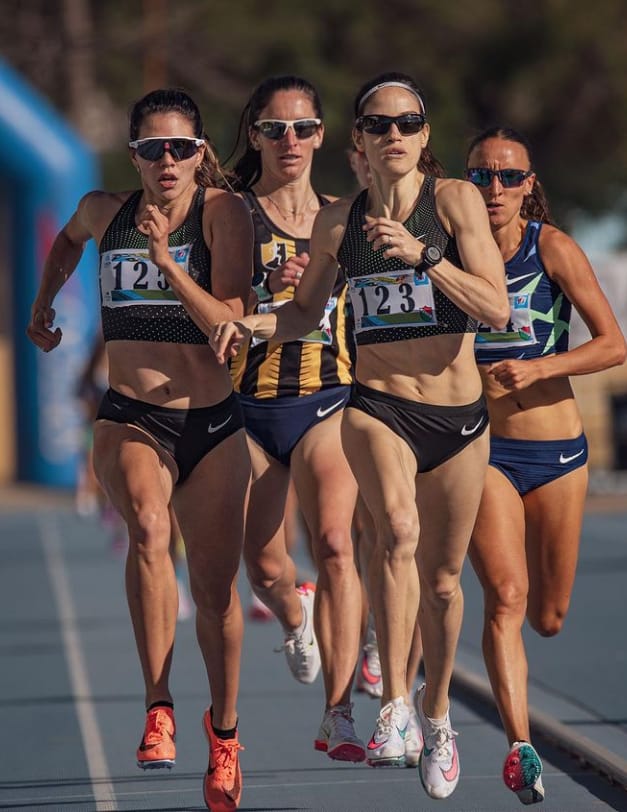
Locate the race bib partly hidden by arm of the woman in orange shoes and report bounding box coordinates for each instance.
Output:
[100,245,191,307]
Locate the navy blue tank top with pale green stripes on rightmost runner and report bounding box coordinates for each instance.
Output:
[475,220,572,364]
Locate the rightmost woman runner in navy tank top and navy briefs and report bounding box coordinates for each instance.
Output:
[467,128,625,804]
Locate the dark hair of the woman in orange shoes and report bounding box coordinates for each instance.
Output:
[129,88,229,188]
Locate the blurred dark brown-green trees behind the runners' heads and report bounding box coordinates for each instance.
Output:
[0,0,627,226]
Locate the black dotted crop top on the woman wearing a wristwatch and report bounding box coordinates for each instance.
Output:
[338,175,476,345]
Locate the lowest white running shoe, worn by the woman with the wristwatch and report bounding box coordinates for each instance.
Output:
[414,685,459,799]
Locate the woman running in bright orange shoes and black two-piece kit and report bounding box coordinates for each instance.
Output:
[28,90,253,809]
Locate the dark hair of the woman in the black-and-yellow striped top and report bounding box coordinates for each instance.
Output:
[226,76,322,189]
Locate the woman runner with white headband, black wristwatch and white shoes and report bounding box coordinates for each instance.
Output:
[211,73,509,798]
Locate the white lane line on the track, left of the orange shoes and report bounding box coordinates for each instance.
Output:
[39,514,118,812]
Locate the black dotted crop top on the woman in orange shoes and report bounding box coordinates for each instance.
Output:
[99,188,211,344]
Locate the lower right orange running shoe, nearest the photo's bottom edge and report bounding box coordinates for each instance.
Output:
[202,710,244,812]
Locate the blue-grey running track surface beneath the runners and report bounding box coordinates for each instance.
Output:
[0,488,627,812]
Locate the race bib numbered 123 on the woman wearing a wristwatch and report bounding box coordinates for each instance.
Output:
[349,268,438,333]
